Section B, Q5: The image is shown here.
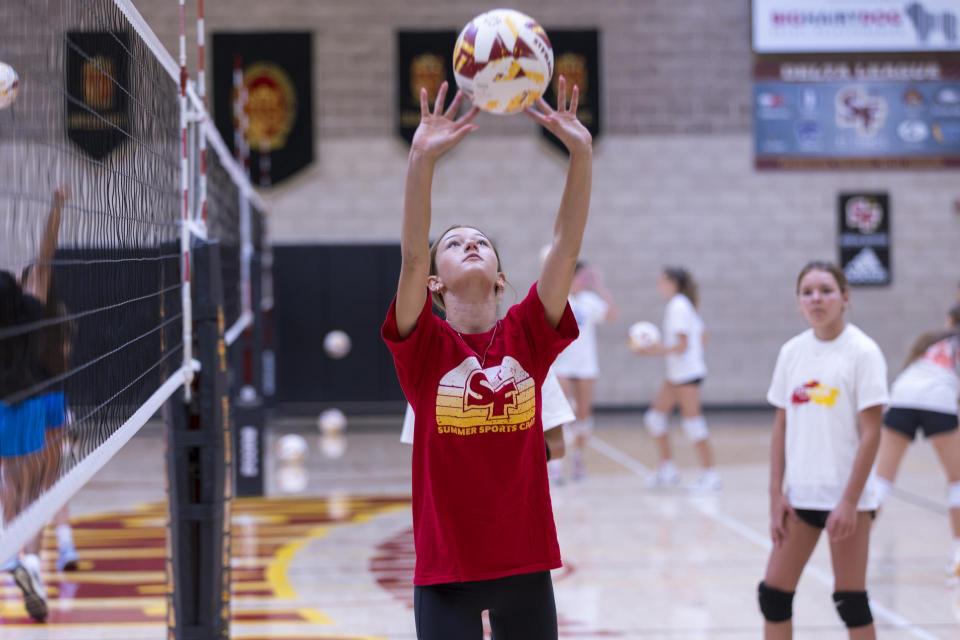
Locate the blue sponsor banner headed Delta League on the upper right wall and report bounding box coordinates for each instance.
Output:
[753,59,960,169]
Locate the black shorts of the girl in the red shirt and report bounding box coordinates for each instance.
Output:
[413,571,557,640]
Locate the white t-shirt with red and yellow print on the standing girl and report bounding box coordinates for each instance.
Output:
[767,324,889,511]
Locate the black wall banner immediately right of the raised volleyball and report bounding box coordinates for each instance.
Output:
[540,29,601,153]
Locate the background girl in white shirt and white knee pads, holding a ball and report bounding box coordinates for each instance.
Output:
[632,267,720,491]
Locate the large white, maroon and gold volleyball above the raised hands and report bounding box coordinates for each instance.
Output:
[453,9,553,114]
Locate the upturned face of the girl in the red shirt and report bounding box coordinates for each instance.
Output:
[436,227,502,289]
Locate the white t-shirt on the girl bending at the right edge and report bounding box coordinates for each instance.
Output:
[890,338,960,415]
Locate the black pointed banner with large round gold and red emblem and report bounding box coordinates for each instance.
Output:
[213,32,314,186]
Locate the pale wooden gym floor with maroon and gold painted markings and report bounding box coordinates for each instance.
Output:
[0,412,960,640]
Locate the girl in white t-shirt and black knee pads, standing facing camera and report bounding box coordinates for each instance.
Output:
[759,262,889,640]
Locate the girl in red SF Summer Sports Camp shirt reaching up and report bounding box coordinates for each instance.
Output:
[383,76,592,640]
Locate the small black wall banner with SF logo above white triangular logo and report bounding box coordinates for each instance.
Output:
[837,193,893,286]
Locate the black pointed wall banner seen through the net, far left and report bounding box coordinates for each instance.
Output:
[64,31,131,160]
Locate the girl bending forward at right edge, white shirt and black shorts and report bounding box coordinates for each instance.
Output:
[877,304,960,578]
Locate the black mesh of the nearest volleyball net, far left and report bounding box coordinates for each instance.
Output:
[0,0,182,544]
